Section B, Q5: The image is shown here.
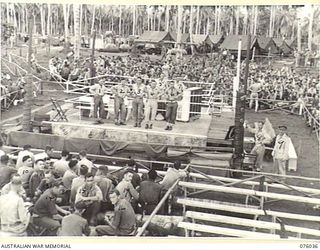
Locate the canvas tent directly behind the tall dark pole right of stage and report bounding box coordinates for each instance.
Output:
[219,35,260,56]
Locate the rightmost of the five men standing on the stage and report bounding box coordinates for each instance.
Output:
[165,82,182,130]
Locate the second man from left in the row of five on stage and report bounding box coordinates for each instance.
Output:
[111,79,130,125]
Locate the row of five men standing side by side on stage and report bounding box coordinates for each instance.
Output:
[89,76,184,130]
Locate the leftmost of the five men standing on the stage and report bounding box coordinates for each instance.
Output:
[89,80,108,123]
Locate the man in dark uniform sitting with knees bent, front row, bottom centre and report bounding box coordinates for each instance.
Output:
[96,189,136,236]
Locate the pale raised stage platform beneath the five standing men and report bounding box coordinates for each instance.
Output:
[45,106,212,147]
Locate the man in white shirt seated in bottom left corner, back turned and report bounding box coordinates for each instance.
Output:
[0,176,30,236]
